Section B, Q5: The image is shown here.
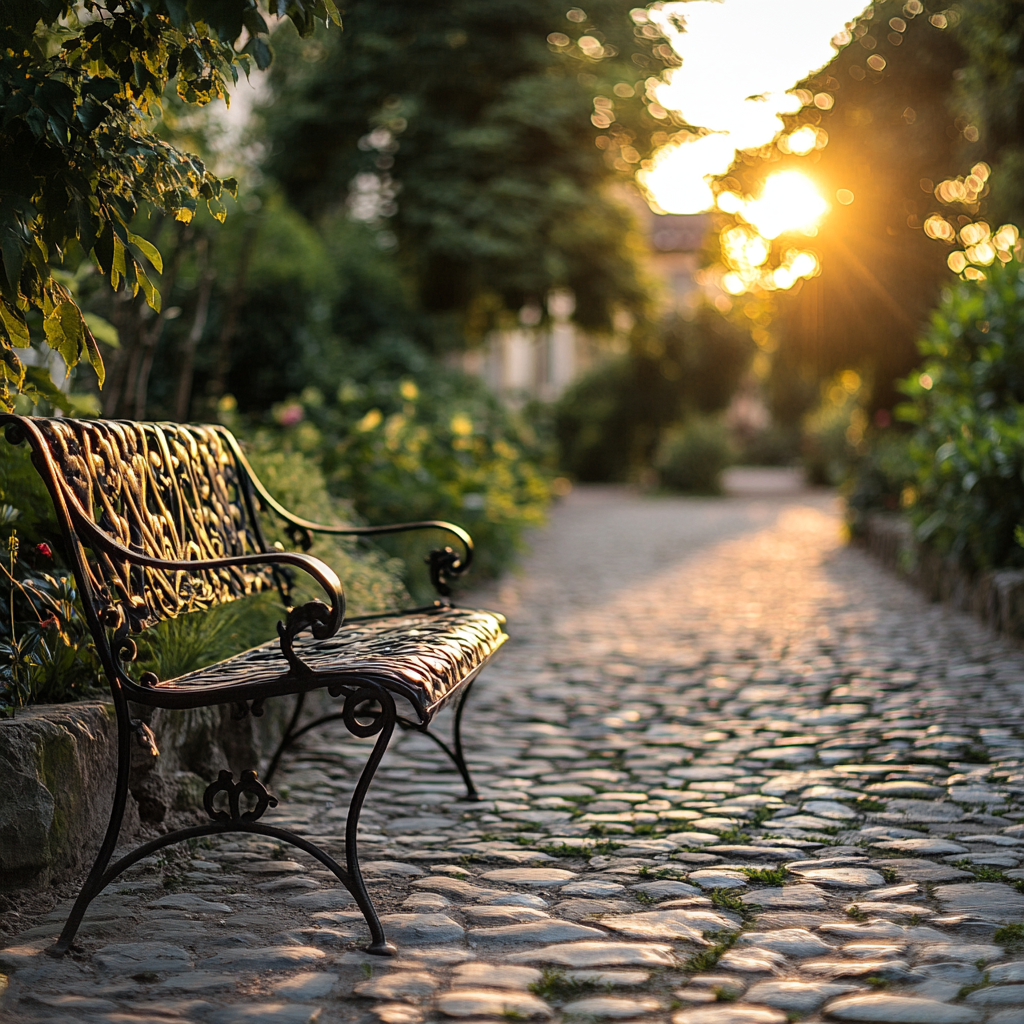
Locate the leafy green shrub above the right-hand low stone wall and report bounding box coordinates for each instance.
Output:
[898,259,1024,568]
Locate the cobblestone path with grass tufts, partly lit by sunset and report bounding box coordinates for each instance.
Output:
[6,488,1024,1024]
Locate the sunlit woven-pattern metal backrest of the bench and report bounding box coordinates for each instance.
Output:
[9,417,274,632]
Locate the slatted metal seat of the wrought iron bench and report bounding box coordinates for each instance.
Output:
[138,608,508,722]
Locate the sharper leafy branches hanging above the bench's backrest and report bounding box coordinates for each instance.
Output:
[0,0,340,409]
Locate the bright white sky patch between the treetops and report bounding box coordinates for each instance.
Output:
[640,0,864,213]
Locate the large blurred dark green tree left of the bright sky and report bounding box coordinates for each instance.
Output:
[256,0,684,340]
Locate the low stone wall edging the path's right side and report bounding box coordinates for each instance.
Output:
[862,513,1024,639]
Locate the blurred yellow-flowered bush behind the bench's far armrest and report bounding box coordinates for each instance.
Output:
[244,367,550,597]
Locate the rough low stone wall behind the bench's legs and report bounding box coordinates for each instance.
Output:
[0,697,317,889]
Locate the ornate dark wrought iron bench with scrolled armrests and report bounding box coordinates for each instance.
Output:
[0,415,507,956]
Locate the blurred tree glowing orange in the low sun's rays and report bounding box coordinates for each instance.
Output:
[719,0,962,419]
